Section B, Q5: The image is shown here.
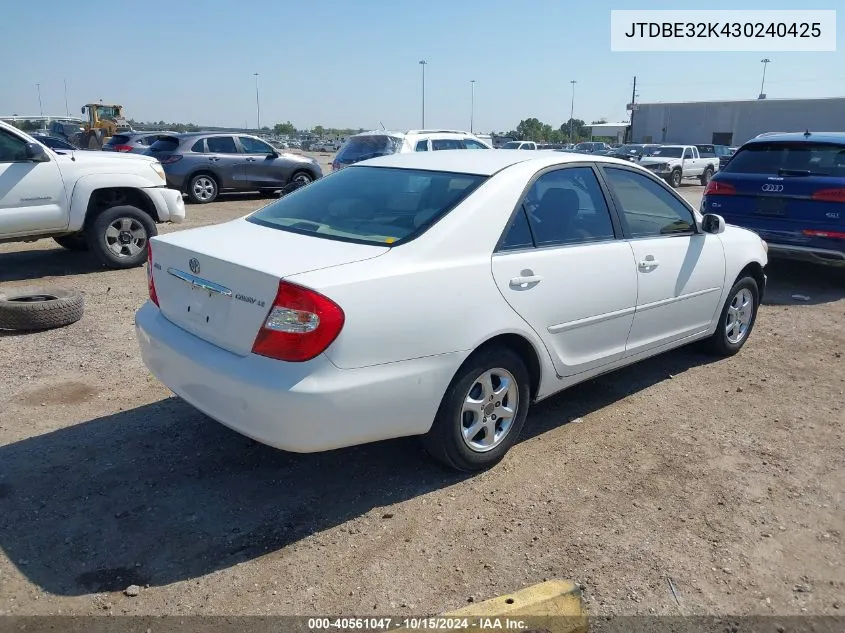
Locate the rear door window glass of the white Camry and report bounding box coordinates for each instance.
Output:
[523,167,615,246]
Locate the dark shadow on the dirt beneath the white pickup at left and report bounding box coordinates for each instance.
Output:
[0,248,103,283]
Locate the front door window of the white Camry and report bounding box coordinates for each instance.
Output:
[604,167,695,237]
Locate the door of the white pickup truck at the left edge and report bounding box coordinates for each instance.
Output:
[0,129,68,236]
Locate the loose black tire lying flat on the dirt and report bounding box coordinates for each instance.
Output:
[0,288,85,331]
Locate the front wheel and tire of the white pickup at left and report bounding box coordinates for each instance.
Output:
[85,205,158,268]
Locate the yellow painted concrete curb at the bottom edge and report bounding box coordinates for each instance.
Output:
[397,580,588,633]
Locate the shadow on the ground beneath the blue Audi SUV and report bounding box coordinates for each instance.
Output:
[763,258,845,305]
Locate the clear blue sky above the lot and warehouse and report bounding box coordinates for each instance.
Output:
[0,0,845,131]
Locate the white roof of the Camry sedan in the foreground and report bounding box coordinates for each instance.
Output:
[347,149,630,176]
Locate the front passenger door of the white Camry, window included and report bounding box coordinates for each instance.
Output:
[602,167,725,355]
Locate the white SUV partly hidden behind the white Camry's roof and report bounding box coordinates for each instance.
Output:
[332,130,493,171]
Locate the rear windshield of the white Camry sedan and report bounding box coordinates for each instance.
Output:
[249,166,485,245]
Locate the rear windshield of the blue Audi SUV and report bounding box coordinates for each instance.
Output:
[722,141,845,177]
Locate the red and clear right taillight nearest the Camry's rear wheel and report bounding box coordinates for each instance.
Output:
[252,281,345,362]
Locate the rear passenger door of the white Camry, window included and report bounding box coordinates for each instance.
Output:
[492,164,637,376]
